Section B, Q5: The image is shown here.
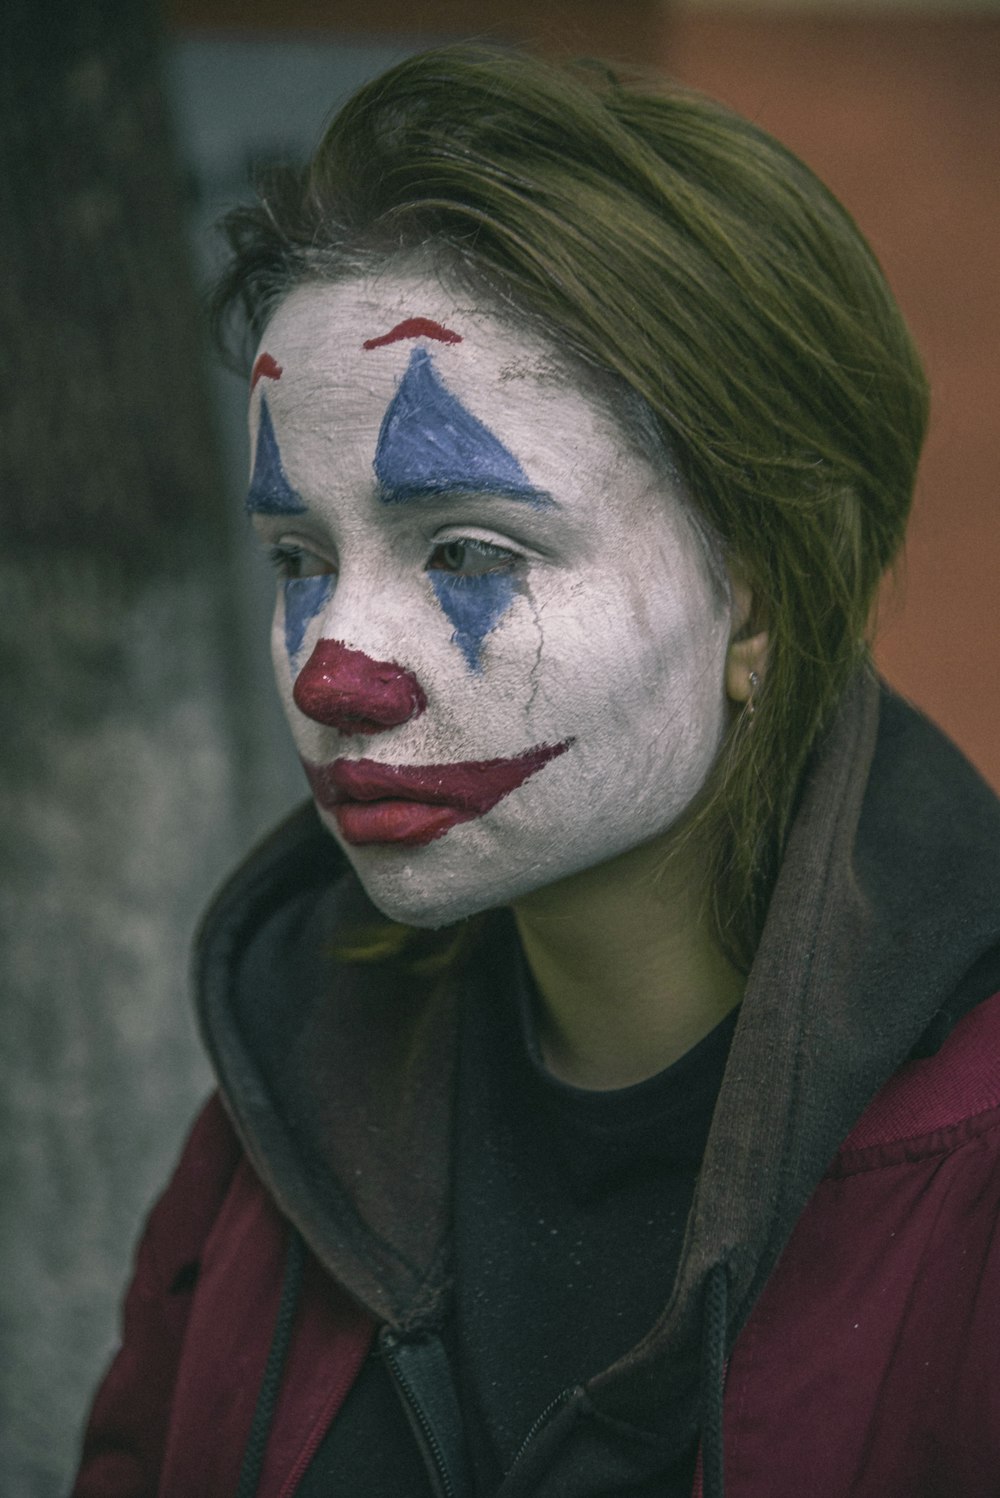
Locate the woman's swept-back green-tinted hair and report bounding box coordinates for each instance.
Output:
[216,46,927,968]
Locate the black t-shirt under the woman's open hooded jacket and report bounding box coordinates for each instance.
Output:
[299,940,735,1498]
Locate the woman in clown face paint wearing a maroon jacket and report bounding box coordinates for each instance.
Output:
[76,48,1000,1498]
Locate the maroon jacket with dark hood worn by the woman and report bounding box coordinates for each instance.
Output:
[73,685,1000,1498]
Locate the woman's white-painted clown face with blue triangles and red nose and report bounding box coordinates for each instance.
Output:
[249,273,731,926]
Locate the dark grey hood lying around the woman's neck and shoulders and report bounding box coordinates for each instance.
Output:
[196,673,1000,1494]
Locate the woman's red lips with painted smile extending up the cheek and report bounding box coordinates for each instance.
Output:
[302,739,573,848]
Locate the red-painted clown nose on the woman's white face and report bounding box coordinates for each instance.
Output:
[292,640,427,734]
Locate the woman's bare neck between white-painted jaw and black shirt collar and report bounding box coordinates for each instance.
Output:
[513,834,744,1089]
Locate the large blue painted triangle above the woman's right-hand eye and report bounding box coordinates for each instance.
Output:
[374,349,552,505]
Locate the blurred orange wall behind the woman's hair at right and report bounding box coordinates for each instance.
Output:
[663,10,1000,789]
